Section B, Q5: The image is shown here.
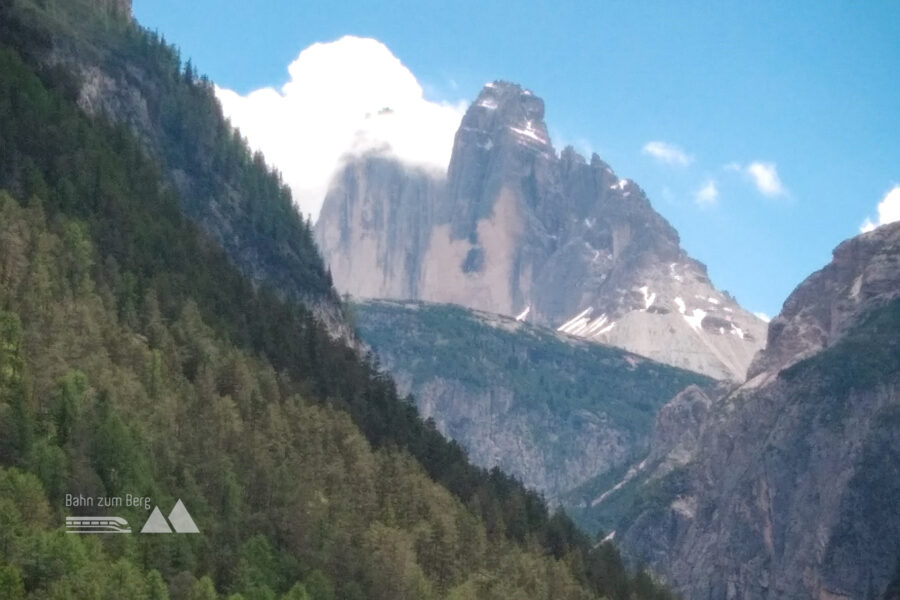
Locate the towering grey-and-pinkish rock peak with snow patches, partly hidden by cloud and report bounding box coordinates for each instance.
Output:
[316,81,765,381]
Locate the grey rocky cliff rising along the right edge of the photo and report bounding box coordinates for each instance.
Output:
[616,224,900,600]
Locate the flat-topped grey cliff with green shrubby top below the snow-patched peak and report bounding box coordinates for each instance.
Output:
[353,300,712,504]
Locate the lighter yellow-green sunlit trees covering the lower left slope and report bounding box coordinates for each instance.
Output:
[0,198,652,600]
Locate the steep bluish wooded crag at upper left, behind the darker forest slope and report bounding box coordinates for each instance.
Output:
[3,0,348,335]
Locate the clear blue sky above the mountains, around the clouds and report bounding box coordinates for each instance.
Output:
[134,0,900,315]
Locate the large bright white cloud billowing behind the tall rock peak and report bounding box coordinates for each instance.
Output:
[216,36,465,219]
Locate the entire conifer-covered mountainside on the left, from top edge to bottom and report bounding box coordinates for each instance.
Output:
[0,0,669,600]
